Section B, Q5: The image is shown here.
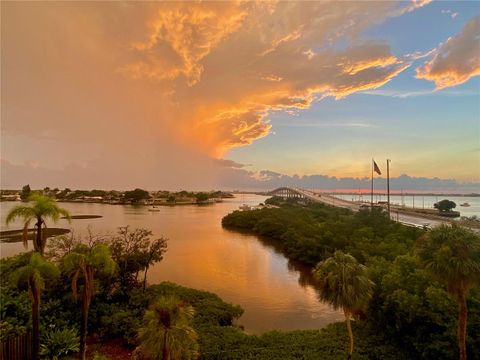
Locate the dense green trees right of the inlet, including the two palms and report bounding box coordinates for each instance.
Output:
[222,199,480,360]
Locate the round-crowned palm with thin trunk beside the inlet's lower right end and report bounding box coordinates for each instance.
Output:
[313,250,374,359]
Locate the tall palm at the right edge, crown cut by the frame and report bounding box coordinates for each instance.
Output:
[416,224,480,360]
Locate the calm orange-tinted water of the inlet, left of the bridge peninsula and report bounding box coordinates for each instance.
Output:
[0,195,343,333]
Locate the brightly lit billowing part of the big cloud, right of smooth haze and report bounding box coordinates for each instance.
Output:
[116,2,408,156]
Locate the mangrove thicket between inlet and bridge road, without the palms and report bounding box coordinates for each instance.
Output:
[222,199,480,360]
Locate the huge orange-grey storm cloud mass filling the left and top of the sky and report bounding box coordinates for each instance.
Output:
[1,0,478,189]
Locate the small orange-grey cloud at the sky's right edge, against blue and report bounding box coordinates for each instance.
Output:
[416,16,480,90]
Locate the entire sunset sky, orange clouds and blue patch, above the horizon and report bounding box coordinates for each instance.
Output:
[0,0,480,192]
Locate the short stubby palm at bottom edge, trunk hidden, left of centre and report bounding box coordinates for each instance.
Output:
[138,296,198,360]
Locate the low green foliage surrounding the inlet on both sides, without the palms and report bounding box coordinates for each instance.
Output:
[0,204,480,360]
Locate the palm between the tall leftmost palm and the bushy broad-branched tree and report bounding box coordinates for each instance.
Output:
[63,244,116,360]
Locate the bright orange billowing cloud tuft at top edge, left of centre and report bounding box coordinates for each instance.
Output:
[121,2,246,85]
